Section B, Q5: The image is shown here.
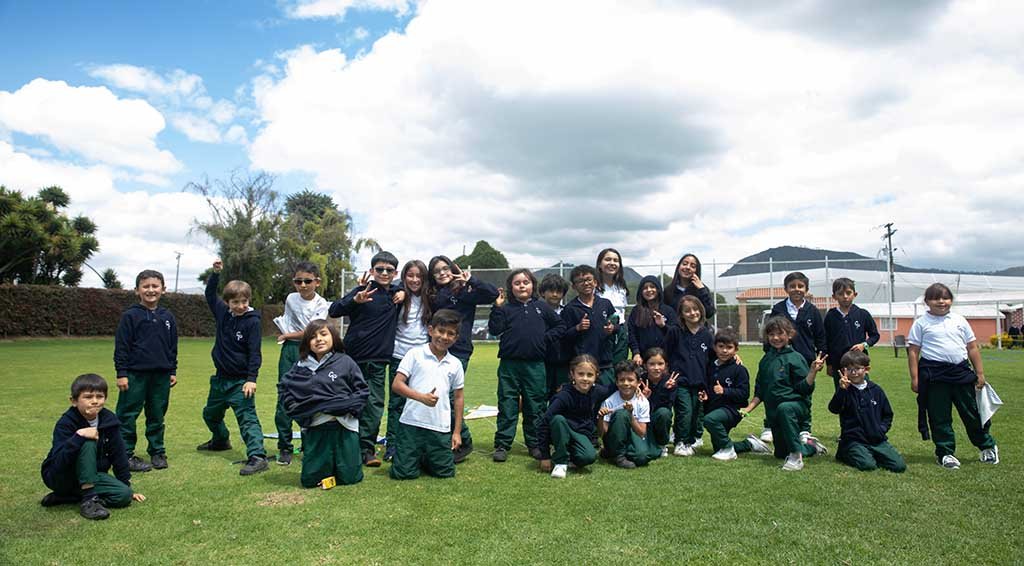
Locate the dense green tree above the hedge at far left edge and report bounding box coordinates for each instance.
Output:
[0,185,99,287]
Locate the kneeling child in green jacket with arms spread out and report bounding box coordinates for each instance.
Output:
[736,316,828,472]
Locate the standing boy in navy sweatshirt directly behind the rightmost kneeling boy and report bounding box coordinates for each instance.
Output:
[824,277,879,390]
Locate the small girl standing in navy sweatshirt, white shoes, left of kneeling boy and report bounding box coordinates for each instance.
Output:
[665,295,715,456]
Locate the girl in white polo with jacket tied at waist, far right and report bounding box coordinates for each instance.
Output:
[906,284,999,470]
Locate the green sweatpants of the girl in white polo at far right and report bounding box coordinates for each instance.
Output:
[928,381,995,458]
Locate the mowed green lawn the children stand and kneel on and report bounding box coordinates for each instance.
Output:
[0,339,1024,565]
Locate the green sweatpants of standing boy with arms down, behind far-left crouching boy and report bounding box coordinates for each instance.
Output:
[116,372,171,456]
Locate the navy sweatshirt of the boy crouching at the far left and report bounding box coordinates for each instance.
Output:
[41,407,131,493]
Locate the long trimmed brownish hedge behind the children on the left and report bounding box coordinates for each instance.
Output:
[0,285,284,338]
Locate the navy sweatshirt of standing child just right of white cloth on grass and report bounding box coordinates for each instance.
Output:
[487,298,565,361]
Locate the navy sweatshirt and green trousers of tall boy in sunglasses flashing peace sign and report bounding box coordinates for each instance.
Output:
[328,280,401,455]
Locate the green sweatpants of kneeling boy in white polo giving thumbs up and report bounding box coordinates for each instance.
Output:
[390,423,455,480]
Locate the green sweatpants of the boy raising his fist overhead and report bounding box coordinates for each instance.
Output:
[203,375,266,458]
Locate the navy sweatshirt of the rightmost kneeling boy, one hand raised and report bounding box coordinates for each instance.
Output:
[828,381,893,445]
